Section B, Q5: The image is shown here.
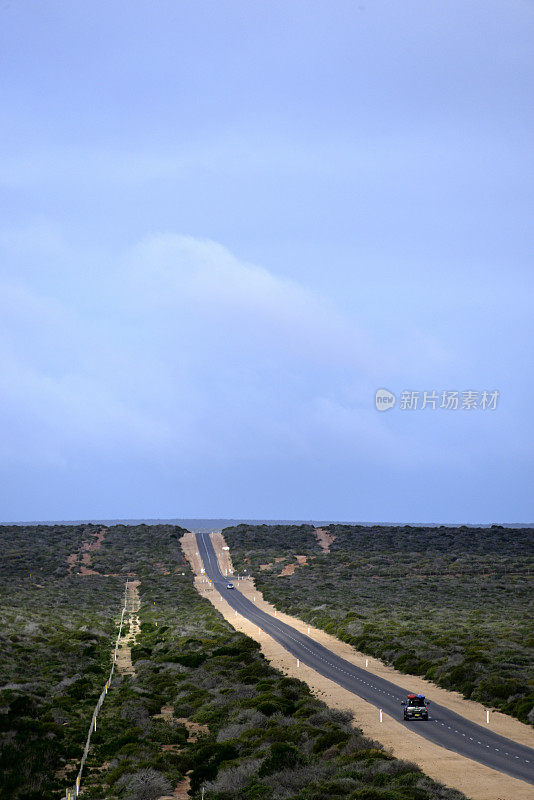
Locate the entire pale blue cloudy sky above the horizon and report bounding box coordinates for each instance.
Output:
[0,0,534,524]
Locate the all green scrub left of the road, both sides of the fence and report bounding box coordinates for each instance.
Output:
[0,525,463,800]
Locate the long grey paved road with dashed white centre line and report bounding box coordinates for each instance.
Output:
[196,533,534,783]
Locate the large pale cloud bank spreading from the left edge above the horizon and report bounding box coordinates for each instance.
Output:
[0,226,478,476]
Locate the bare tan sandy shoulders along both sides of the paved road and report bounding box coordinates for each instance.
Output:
[182,534,534,800]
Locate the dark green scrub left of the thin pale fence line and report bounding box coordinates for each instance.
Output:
[0,526,124,800]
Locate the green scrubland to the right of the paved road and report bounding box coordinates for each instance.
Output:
[223,525,534,724]
